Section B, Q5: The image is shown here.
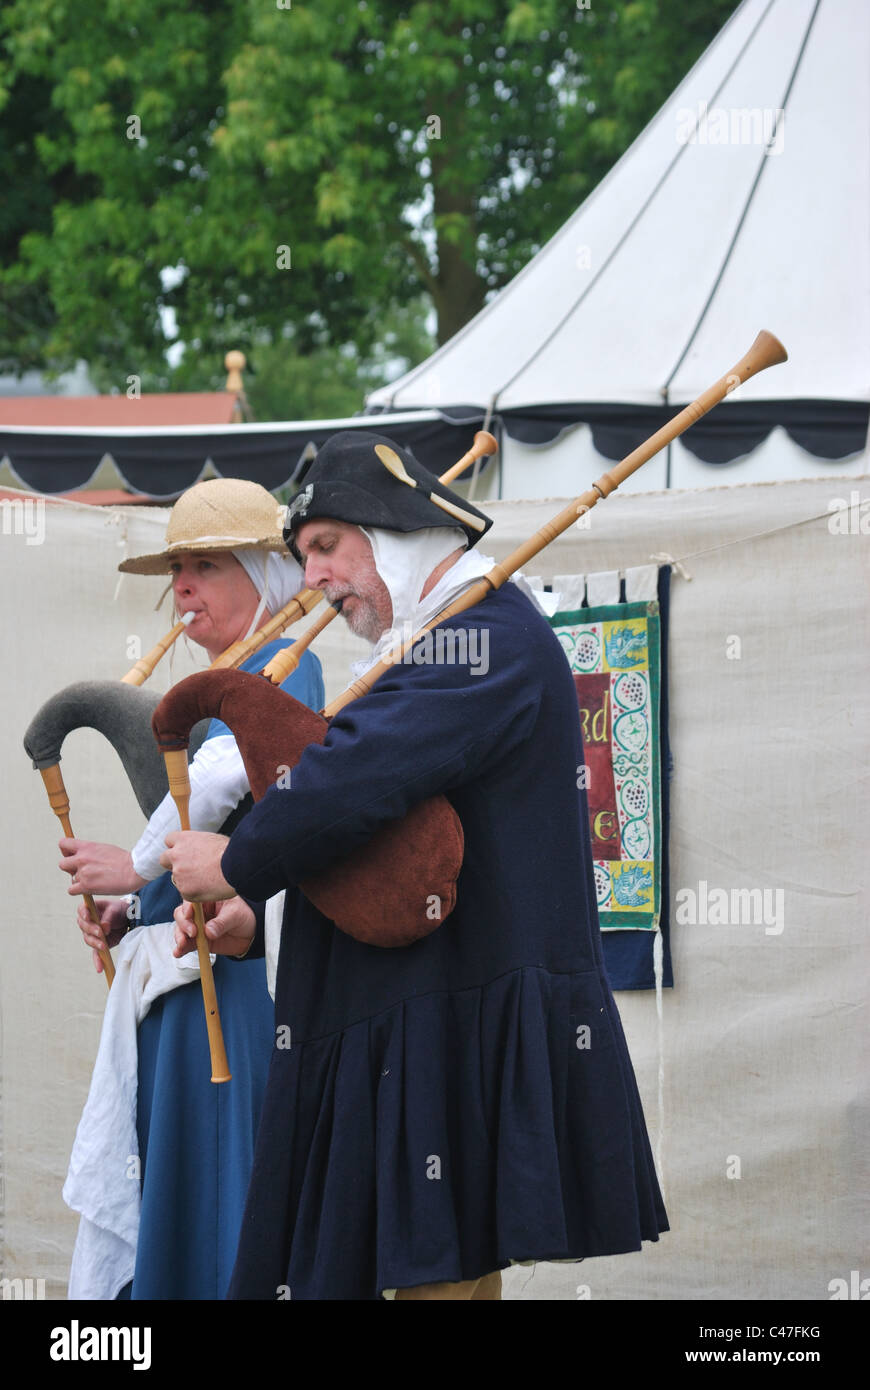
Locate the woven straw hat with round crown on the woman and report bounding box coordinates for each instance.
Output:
[118,478,286,574]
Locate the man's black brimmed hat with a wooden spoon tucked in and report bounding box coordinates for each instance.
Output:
[284,430,492,550]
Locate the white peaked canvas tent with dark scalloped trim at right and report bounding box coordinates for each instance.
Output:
[368,0,870,498]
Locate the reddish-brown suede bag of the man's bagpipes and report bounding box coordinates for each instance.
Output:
[151,670,464,947]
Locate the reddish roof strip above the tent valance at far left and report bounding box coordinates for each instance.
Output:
[0,391,236,430]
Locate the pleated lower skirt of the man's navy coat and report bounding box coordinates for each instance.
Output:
[229,966,667,1300]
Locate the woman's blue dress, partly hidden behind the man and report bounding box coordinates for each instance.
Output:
[120,641,324,1300]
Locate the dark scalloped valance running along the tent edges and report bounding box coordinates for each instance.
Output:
[0,400,870,502]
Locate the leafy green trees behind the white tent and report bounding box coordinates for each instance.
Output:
[0,0,734,391]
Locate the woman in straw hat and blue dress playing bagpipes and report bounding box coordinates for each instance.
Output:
[60,478,324,1298]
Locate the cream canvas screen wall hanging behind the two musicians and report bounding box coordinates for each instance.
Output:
[0,477,870,1300]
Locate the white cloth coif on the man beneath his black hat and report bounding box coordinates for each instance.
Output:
[352,525,495,677]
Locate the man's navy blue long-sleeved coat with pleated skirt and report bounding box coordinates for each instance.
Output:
[222,585,667,1298]
